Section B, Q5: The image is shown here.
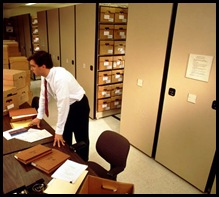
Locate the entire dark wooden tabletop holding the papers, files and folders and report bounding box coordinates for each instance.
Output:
[3,105,96,194]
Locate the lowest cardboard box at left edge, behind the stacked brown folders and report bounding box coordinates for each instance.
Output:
[3,86,19,115]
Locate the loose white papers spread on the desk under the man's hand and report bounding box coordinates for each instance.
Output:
[3,127,52,143]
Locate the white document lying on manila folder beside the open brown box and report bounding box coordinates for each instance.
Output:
[51,159,88,183]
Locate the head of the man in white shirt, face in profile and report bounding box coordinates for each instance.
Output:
[27,51,53,77]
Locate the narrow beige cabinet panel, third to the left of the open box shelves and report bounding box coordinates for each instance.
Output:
[47,8,61,66]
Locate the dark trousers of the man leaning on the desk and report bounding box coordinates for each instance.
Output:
[63,95,90,161]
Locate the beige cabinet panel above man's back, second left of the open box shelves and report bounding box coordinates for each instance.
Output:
[59,6,75,76]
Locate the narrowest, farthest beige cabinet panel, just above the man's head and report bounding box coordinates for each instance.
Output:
[37,11,48,52]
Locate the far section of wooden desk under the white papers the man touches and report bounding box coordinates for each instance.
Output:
[3,103,55,155]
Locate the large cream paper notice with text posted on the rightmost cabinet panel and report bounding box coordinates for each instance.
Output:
[186,54,213,82]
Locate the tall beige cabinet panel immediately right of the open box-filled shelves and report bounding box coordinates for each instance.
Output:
[120,3,172,156]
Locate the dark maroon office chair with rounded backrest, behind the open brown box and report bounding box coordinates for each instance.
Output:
[87,130,130,181]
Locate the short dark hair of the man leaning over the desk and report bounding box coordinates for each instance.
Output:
[27,51,53,68]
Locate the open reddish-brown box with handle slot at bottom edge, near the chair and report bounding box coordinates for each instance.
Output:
[78,175,134,194]
